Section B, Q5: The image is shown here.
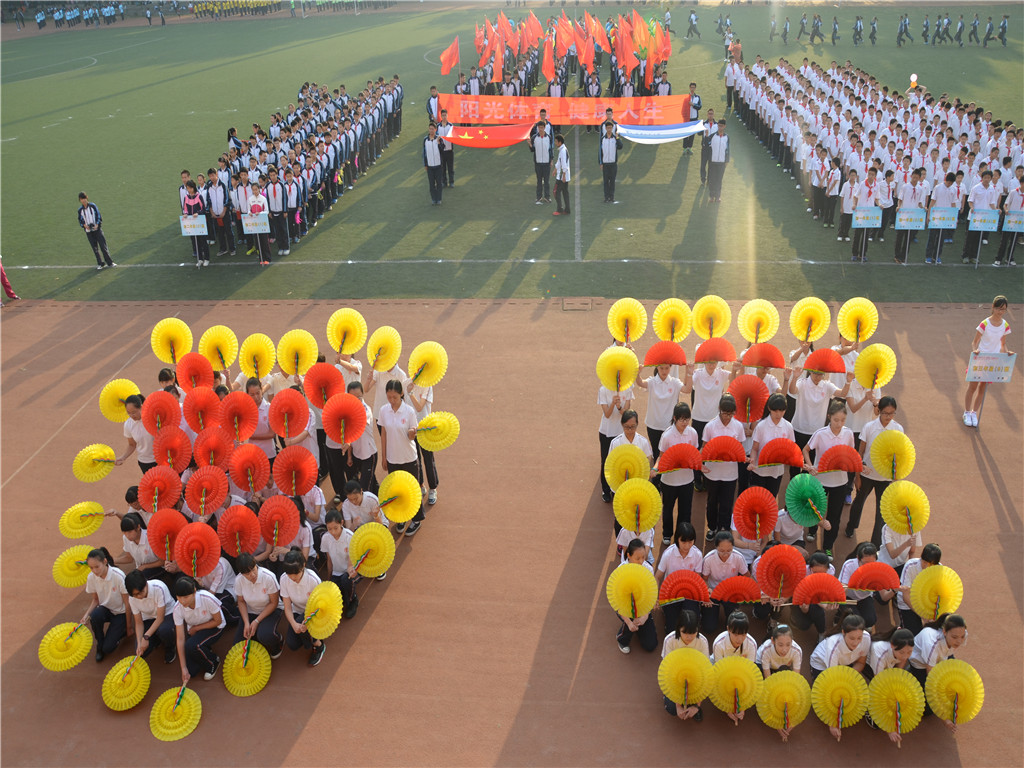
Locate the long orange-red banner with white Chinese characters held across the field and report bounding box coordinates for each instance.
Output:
[438,93,690,125]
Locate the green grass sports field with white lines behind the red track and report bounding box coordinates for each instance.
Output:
[0,3,1024,302]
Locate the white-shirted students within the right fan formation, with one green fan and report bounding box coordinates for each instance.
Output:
[598,337,967,738]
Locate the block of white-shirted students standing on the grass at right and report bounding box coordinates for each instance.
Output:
[725,56,1024,265]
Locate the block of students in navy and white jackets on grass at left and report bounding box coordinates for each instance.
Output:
[178,74,403,267]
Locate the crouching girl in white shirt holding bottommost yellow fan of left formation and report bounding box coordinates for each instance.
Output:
[173,577,225,685]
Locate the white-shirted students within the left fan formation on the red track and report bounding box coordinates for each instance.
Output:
[82,342,438,682]
